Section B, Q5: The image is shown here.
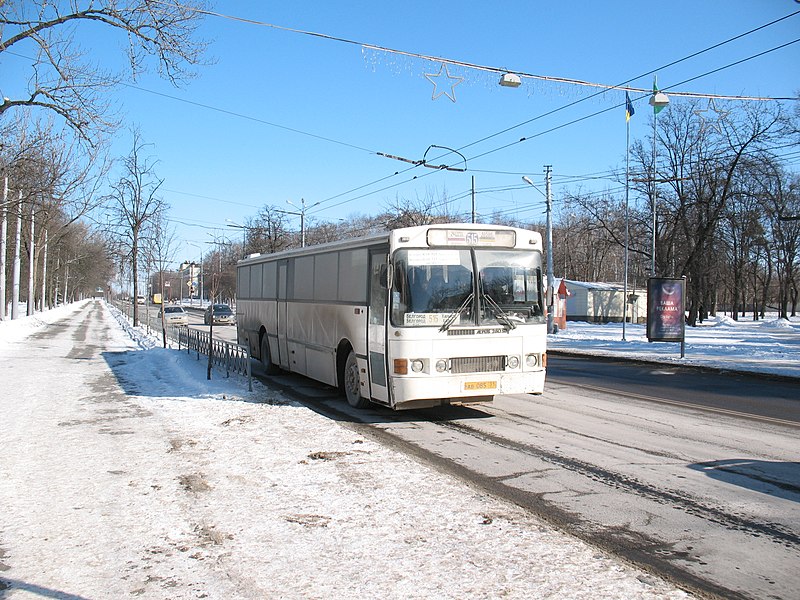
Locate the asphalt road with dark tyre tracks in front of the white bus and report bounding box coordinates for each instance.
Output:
[266,356,800,599]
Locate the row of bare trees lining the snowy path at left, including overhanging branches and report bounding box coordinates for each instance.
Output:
[0,0,207,328]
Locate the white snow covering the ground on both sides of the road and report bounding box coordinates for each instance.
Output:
[0,302,800,600]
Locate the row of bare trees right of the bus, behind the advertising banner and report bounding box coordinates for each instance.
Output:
[554,102,800,324]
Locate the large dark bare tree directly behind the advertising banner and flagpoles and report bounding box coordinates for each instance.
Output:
[634,103,788,325]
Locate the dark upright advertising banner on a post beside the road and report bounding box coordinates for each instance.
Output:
[647,277,686,342]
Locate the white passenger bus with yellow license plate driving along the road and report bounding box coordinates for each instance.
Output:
[236,224,547,409]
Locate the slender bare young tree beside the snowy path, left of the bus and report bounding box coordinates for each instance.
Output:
[108,129,165,325]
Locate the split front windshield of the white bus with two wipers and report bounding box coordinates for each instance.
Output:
[391,248,544,330]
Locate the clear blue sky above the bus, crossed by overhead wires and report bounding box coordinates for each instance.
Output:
[0,0,800,258]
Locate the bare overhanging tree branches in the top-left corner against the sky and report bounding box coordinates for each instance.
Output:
[0,0,207,145]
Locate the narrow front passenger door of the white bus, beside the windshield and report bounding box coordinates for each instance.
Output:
[367,248,389,404]
